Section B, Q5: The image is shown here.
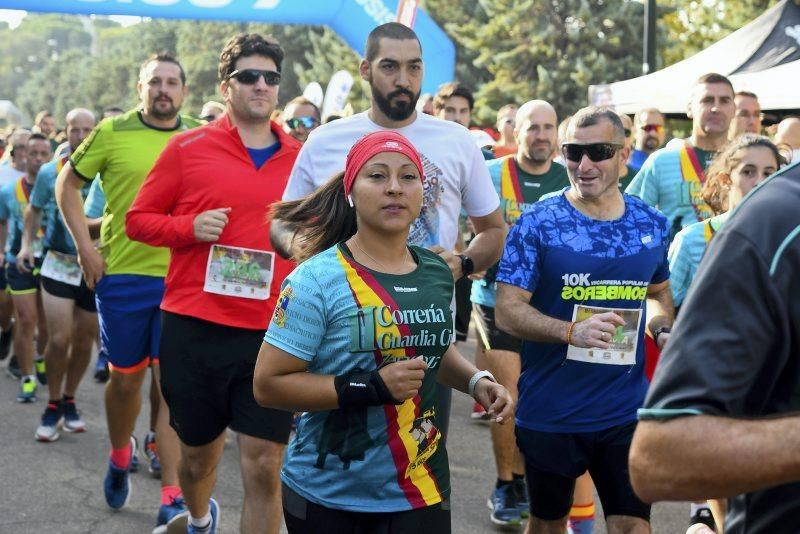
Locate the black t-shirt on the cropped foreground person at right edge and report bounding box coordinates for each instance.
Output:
[639,165,800,534]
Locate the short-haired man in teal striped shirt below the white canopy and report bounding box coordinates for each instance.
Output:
[625,73,735,237]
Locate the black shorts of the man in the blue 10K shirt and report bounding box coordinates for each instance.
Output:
[516,422,650,521]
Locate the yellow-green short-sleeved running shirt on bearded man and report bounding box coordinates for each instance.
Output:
[70,109,202,277]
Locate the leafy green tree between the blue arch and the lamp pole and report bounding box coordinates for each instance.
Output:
[448,0,643,121]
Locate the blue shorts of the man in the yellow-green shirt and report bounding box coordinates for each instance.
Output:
[95,274,164,373]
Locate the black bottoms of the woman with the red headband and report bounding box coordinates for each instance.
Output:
[282,484,451,534]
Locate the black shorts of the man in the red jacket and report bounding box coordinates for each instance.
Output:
[159,311,292,447]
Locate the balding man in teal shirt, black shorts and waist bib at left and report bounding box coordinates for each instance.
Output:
[17,108,97,441]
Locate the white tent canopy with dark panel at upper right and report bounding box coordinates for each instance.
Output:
[609,0,800,114]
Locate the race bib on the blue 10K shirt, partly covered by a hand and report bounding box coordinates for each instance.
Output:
[567,304,642,365]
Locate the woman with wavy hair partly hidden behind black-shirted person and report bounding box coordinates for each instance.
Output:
[669,134,783,314]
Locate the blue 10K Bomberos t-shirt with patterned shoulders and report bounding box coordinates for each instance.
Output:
[497,193,669,433]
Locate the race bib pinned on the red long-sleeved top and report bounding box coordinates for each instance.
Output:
[203,245,275,300]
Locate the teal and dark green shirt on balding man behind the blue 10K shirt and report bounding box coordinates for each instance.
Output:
[470,156,569,308]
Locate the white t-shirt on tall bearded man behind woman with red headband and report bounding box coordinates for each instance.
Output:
[283,111,500,250]
